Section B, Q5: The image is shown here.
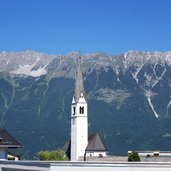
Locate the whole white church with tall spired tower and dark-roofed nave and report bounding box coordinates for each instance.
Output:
[64,58,107,161]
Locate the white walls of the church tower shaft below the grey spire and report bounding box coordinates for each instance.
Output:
[71,97,88,161]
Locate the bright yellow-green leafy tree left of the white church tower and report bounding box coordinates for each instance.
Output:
[37,149,66,161]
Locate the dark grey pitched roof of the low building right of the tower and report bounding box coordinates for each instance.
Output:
[86,133,107,151]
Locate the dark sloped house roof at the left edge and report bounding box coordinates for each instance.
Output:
[0,129,21,148]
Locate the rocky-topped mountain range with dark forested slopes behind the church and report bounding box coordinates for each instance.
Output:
[0,50,171,159]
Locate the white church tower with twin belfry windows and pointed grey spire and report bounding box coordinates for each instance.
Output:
[71,58,88,161]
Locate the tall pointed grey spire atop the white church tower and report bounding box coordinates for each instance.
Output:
[74,57,85,102]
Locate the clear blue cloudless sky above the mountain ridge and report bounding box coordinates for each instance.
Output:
[0,0,171,54]
